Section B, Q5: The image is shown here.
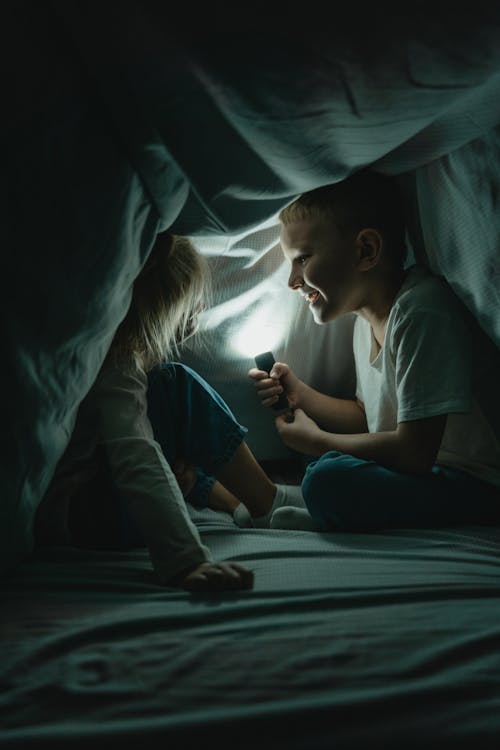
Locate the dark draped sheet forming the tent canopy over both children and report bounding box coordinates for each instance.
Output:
[0,0,500,570]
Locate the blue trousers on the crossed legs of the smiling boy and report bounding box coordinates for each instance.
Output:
[302,451,500,531]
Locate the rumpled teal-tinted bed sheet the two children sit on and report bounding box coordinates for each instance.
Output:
[0,511,500,750]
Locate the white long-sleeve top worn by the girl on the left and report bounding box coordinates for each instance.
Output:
[39,358,212,583]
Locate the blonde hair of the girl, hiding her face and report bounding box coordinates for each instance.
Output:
[112,232,209,371]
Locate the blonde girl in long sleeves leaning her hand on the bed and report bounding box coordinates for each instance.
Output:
[35,233,302,591]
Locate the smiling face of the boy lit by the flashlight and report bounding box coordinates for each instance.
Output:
[280,217,361,323]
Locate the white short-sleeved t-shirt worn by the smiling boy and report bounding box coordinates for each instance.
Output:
[353,266,500,494]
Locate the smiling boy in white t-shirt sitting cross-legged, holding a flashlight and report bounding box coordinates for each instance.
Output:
[249,169,500,531]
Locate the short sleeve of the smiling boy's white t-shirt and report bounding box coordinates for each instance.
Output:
[391,309,472,422]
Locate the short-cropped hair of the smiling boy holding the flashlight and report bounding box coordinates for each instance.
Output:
[278,169,407,264]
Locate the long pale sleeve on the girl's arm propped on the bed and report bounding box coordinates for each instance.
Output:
[92,362,212,583]
